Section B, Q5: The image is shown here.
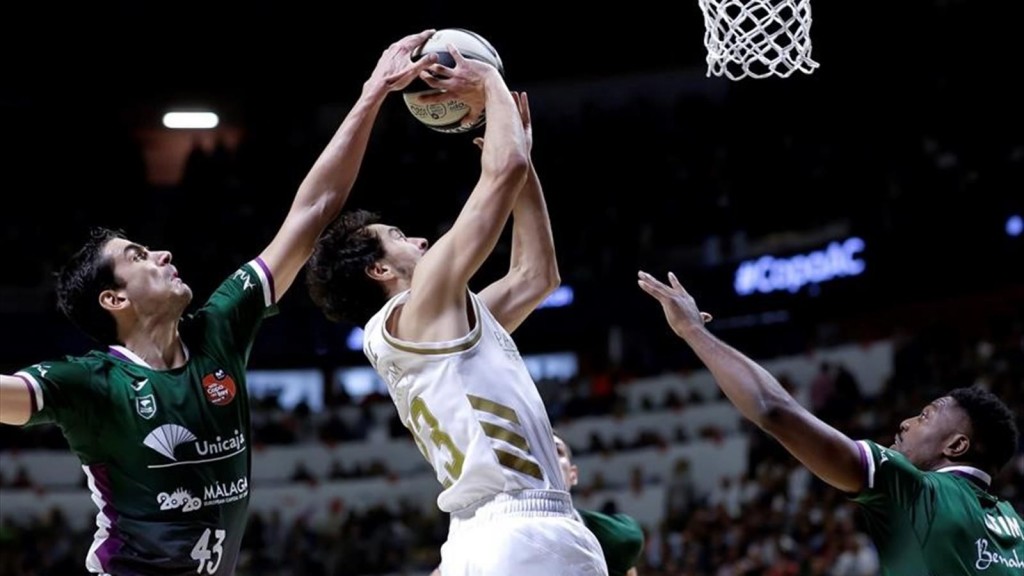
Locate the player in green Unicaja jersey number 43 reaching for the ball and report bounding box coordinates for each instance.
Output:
[0,30,435,576]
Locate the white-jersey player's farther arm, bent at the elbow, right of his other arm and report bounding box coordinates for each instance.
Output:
[480,92,561,332]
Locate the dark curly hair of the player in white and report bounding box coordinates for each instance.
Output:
[306,210,387,326]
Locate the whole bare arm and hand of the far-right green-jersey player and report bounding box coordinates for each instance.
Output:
[638,272,866,493]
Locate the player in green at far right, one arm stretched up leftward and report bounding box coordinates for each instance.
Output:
[638,272,1024,576]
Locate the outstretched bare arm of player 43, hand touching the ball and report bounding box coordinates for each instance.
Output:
[260,30,436,298]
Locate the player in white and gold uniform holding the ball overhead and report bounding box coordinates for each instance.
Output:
[306,46,607,576]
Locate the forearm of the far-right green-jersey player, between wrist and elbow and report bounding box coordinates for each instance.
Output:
[683,326,796,426]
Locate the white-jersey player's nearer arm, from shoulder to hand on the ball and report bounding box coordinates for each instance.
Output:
[396,46,529,341]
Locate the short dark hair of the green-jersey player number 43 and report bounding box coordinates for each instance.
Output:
[56,227,125,344]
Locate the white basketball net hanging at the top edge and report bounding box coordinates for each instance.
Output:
[697,0,818,80]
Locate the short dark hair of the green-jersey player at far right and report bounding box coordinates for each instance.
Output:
[948,385,1018,472]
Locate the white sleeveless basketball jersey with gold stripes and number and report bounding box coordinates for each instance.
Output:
[362,291,566,512]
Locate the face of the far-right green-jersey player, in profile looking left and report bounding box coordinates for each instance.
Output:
[892,397,970,470]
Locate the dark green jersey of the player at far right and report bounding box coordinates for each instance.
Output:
[854,442,1024,576]
